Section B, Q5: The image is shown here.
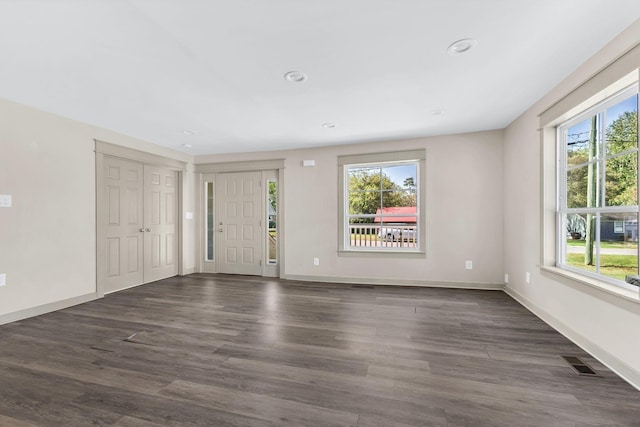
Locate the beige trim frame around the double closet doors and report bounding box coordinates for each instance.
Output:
[94,139,187,298]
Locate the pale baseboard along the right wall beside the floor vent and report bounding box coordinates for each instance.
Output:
[504,287,640,390]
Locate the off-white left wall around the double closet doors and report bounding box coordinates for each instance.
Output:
[0,100,194,323]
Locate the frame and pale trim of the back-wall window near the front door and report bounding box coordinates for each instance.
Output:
[338,149,426,258]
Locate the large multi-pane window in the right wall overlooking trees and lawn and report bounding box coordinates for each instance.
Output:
[557,84,638,287]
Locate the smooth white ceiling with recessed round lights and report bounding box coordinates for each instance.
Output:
[0,0,640,155]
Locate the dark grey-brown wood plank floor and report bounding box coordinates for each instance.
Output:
[0,275,640,427]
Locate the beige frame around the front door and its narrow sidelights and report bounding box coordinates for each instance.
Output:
[194,159,285,278]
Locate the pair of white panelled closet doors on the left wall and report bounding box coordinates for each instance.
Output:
[97,156,179,293]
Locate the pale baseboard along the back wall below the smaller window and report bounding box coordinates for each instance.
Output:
[283,274,504,291]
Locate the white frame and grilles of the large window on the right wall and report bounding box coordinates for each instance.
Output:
[556,82,640,290]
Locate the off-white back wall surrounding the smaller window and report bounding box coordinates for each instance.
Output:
[196,131,503,288]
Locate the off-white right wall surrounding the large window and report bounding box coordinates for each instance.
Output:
[503,21,640,388]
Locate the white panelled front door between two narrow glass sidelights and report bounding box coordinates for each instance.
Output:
[215,172,264,275]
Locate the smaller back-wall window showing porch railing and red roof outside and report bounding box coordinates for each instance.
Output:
[341,152,424,252]
